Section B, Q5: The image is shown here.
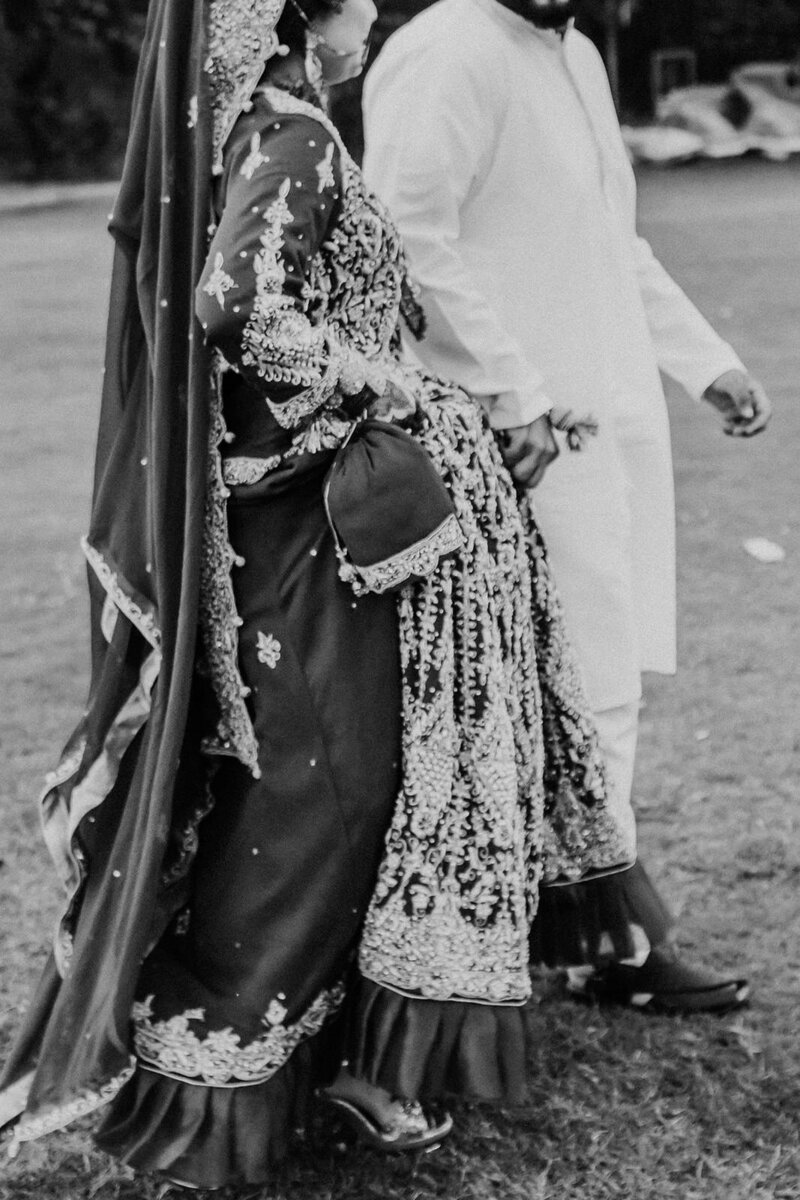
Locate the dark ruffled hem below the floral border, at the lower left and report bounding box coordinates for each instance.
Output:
[95,1039,331,1188]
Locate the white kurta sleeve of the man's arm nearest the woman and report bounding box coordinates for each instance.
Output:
[365,42,551,428]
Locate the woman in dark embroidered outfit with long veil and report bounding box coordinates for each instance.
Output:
[0,0,632,1187]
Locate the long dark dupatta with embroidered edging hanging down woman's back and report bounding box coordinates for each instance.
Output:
[0,0,282,1145]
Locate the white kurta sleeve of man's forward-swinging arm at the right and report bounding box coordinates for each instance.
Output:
[633,236,745,400]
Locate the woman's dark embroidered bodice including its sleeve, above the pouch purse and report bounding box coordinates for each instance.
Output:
[197,88,419,468]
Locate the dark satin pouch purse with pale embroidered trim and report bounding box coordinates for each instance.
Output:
[323,418,464,595]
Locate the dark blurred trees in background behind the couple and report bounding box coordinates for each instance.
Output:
[0,0,800,179]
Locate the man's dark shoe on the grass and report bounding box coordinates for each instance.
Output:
[567,946,750,1014]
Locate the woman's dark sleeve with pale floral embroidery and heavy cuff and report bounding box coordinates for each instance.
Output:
[197,114,384,428]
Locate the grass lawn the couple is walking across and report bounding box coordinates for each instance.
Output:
[0,162,800,1200]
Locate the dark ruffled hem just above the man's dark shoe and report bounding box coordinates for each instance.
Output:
[530,863,673,967]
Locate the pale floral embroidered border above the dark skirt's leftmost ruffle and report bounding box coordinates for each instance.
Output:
[133,984,344,1087]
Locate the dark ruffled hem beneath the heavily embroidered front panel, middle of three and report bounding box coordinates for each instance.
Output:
[345,979,527,1104]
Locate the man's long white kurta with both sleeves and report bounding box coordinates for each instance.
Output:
[365,0,741,709]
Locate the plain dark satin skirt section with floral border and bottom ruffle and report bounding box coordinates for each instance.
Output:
[97,456,402,1187]
